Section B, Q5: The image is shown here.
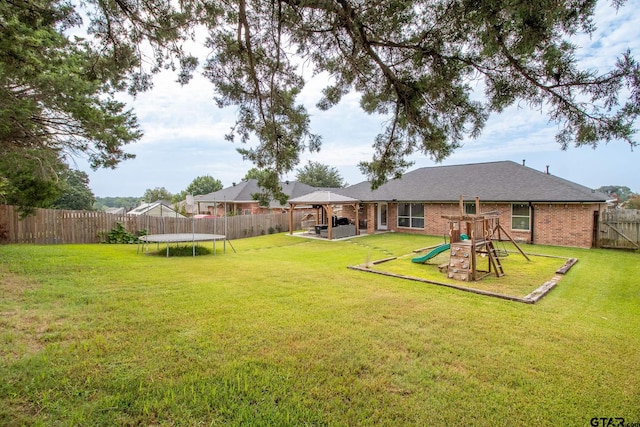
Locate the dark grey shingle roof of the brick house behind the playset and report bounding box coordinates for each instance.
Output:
[340,161,607,203]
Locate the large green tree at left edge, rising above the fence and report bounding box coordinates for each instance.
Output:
[0,0,142,213]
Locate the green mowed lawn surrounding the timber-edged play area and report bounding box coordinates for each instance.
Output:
[0,234,640,426]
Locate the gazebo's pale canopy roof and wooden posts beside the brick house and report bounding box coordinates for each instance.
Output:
[289,190,360,240]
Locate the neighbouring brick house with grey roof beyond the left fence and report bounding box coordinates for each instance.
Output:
[187,179,317,216]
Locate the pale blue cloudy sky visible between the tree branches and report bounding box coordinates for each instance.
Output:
[75,0,640,197]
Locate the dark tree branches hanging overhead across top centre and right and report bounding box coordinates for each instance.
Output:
[200,0,640,187]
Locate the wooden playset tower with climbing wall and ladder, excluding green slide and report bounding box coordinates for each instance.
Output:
[442,196,529,281]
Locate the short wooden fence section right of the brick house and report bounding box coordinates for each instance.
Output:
[597,209,640,249]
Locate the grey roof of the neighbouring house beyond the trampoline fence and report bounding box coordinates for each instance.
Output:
[194,179,316,208]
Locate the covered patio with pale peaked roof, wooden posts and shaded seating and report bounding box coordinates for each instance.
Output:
[289,190,360,240]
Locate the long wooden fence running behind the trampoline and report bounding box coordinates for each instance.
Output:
[0,205,303,244]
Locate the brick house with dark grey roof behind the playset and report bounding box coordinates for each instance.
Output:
[334,161,608,248]
